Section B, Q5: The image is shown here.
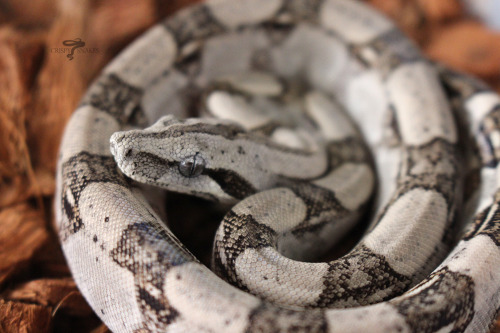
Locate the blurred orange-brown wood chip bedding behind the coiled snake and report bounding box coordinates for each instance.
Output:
[0,0,500,333]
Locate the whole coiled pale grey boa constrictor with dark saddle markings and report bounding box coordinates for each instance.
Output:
[56,0,500,332]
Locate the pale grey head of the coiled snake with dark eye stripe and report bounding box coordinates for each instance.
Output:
[110,116,256,203]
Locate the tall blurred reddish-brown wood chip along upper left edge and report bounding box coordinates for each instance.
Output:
[0,27,42,209]
